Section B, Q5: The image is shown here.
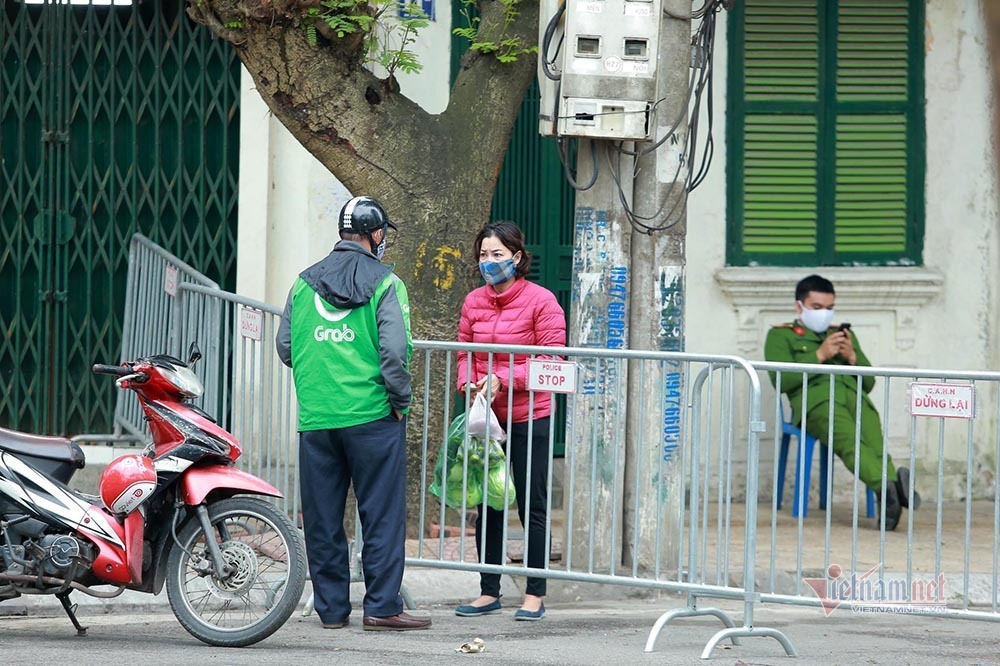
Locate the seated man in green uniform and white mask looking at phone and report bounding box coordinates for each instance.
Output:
[764,275,920,530]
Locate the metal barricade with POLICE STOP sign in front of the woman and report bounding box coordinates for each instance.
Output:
[407,341,794,657]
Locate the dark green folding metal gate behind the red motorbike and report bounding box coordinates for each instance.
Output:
[0,0,240,434]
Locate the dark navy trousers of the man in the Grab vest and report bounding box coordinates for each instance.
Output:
[299,413,406,623]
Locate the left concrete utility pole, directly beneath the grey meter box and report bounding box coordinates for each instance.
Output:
[564,141,632,571]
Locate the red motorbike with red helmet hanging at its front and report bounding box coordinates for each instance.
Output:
[0,345,306,647]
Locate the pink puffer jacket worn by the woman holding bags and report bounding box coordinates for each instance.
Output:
[458,278,566,428]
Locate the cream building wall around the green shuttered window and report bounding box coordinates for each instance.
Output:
[687,0,1000,496]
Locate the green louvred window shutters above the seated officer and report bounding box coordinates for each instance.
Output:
[727,0,925,265]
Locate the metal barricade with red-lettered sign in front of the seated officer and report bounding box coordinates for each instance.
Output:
[747,363,1000,621]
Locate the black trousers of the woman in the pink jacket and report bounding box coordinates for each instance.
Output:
[476,417,549,597]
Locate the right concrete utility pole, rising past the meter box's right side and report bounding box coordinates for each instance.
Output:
[623,0,691,569]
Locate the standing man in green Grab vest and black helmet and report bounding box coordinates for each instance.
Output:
[275,197,431,631]
